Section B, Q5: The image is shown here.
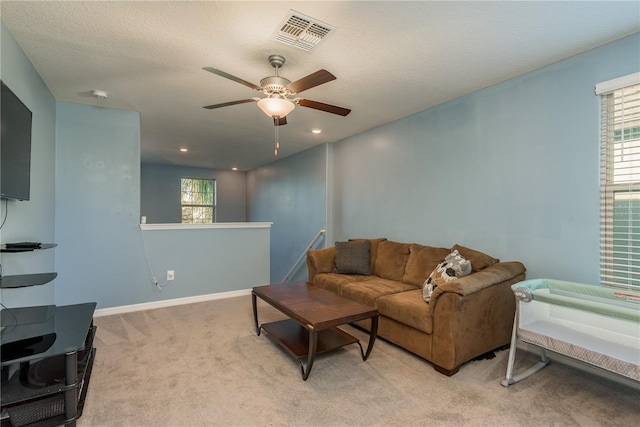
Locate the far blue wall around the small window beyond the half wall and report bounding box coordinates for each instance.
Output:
[140,163,247,223]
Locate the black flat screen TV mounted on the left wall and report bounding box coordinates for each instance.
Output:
[0,82,31,200]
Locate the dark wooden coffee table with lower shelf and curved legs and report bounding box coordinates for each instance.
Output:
[251,282,378,381]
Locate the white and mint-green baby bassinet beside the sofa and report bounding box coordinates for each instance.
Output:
[501,279,640,387]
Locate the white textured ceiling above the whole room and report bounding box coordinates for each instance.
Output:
[0,0,640,170]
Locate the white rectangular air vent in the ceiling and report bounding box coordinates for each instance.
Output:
[271,9,336,52]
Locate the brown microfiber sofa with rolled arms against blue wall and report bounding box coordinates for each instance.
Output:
[307,239,526,375]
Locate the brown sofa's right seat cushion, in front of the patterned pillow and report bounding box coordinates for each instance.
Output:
[378,289,433,334]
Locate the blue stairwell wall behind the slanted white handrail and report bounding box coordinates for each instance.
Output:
[247,145,327,283]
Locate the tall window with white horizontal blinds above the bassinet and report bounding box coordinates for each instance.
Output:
[596,73,640,290]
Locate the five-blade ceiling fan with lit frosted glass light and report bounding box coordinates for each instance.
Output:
[203,55,351,126]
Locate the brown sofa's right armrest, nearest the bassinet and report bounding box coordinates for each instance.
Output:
[429,262,526,371]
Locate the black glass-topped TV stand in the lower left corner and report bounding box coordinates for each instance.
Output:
[0,302,96,427]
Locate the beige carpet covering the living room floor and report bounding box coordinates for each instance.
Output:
[78,296,640,427]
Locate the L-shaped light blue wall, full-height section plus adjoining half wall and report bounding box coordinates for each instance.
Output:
[55,105,269,308]
